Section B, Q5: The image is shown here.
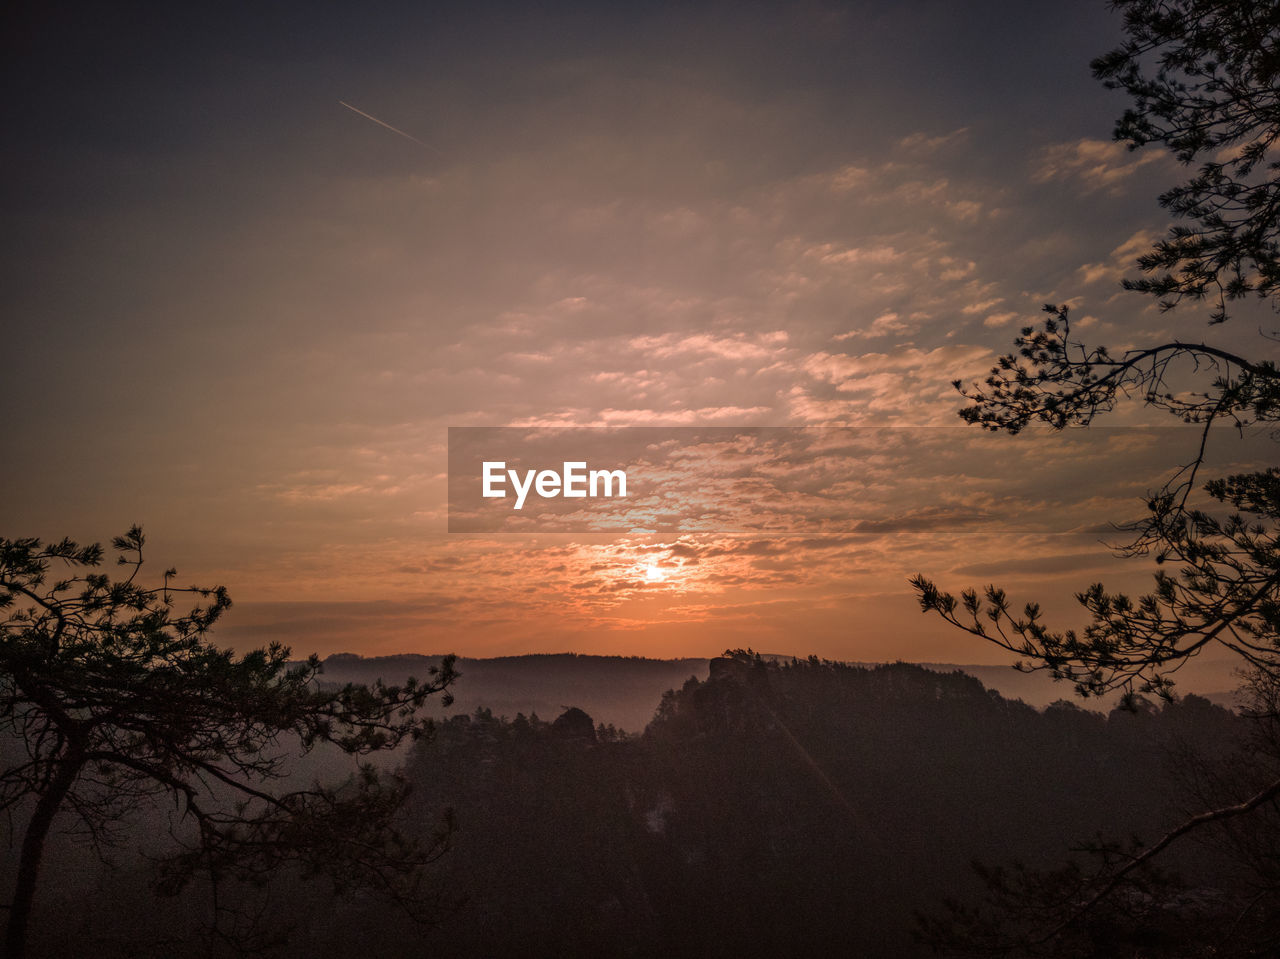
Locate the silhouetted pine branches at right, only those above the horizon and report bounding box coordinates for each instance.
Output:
[914,0,1280,727]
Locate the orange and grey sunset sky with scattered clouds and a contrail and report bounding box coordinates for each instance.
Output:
[0,0,1274,662]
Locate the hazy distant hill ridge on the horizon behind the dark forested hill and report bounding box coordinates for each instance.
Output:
[314,653,1234,732]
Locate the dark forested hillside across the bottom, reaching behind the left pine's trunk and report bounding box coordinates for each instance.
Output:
[6,652,1248,958]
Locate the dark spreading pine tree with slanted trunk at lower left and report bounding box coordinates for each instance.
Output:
[0,528,454,959]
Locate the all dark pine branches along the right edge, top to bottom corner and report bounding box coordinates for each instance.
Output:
[914,0,1280,955]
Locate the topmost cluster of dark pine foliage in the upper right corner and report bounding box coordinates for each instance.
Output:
[1093,0,1280,323]
